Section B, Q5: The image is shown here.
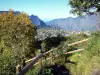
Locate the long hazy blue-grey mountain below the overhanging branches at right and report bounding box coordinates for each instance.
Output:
[46,15,98,31]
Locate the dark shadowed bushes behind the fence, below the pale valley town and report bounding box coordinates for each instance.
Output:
[34,35,66,52]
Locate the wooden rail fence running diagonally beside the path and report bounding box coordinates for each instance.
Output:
[16,38,90,75]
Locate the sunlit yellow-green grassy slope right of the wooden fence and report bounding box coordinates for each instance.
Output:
[71,31,100,75]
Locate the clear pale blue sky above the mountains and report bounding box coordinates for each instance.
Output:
[0,0,75,21]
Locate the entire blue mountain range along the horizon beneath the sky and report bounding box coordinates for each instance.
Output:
[0,11,98,31]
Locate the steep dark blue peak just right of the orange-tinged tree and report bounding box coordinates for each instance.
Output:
[30,15,50,28]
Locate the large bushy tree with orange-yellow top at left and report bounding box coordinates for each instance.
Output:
[0,10,36,75]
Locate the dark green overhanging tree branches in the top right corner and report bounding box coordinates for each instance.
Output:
[69,0,100,29]
